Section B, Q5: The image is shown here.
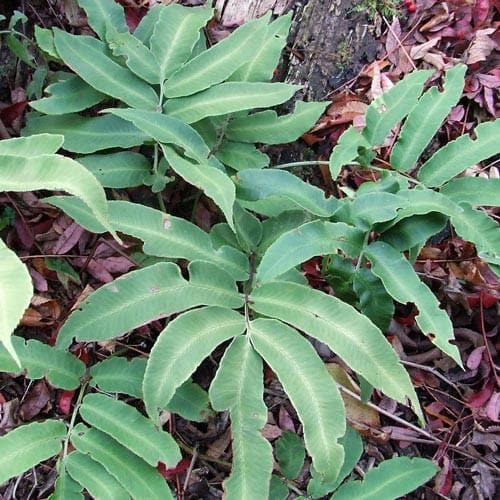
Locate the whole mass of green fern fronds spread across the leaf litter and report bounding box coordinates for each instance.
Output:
[0,0,499,499]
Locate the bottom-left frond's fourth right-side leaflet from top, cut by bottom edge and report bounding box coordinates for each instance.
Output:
[62,451,130,500]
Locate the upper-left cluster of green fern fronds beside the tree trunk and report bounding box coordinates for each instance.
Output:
[24,0,327,219]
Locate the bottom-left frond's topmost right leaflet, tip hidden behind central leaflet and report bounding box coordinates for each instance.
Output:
[90,357,146,399]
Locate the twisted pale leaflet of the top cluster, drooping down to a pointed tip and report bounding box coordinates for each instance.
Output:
[161,144,236,230]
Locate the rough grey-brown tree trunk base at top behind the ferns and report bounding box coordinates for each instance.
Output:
[214,0,376,100]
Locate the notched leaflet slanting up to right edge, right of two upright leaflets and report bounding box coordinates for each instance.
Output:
[418,120,500,188]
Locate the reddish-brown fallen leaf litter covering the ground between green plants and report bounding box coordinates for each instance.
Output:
[0,0,500,500]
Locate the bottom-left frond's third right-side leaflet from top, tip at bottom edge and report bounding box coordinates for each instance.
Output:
[71,424,173,500]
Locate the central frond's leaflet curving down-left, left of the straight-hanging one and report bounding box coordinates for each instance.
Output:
[143,306,245,421]
